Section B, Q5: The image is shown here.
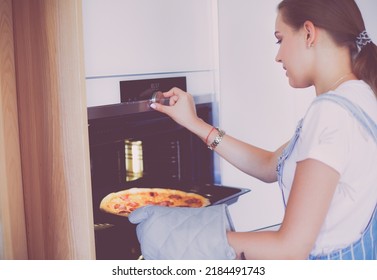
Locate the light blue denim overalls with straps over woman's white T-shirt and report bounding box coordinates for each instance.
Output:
[277,94,377,260]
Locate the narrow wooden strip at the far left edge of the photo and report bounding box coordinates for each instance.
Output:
[0,0,27,259]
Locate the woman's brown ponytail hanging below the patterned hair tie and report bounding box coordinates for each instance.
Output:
[353,42,377,98]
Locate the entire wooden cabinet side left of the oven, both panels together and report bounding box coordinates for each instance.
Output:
[0,0,95,259]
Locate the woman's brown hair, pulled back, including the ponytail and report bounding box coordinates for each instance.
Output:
[278,0,377,96]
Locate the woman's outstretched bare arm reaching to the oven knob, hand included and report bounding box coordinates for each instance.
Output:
[152,88,285,182]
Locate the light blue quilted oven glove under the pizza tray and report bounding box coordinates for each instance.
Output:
[129,204,236,260]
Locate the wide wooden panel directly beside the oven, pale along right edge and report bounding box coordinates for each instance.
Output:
[13,0,95,259]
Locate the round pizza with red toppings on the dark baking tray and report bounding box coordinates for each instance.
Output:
[100,188,210,217]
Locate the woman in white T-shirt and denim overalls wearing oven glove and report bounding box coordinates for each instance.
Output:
[130,0,377,259]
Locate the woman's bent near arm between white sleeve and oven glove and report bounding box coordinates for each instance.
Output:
[228,159,339,259]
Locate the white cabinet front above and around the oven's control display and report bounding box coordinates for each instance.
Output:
[83,0,217,107]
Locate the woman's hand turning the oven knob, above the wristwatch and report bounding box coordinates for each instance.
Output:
[151,87,201,131]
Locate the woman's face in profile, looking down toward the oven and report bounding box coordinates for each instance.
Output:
[275,12,313,88]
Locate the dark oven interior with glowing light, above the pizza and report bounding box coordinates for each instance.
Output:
[91,130,188,188]
